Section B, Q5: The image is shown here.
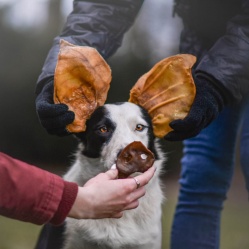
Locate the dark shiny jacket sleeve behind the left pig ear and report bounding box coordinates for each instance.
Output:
[36,0,143,94]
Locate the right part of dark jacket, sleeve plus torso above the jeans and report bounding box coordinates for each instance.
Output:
[174,0,249,103]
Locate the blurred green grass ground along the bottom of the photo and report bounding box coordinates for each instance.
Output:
[0,168,249,249]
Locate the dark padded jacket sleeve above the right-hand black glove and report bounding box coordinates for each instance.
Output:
[196,0,249,103]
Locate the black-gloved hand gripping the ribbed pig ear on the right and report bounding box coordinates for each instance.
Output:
[164,77,224,141]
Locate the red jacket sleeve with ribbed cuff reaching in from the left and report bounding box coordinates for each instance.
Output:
[0,152,78,225]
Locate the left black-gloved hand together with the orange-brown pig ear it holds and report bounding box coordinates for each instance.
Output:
[36,40,112,136]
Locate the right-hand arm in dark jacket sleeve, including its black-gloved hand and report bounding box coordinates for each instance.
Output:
[165,0,249,141]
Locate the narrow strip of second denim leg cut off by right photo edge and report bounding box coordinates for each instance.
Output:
[240,101,249,197]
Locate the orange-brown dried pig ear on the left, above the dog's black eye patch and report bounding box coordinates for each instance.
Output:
[54,40,112,133]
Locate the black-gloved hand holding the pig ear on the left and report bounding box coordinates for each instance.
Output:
[36,80,74,136]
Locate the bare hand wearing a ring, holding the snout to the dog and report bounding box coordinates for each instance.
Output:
[68,166,155,219]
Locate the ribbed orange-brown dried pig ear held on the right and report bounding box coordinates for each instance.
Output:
[129,54,196,138]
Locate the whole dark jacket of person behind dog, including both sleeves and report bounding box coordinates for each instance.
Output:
[36,0,249,102]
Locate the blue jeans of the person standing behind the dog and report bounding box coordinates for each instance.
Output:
[171,99,249,249]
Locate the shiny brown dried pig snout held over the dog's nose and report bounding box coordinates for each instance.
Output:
[116,141,155,178]
